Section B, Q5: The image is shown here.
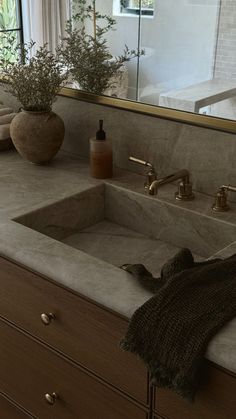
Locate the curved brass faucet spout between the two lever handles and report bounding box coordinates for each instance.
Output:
[148,169,194,201]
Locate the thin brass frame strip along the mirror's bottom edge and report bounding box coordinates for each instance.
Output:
[59,87,236,134]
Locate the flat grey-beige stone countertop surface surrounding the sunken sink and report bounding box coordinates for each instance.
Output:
[0,151,236,373]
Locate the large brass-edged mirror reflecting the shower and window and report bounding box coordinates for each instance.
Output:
[0,0,236,129]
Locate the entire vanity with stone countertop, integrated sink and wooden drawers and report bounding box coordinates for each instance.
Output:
[0,153,236,419]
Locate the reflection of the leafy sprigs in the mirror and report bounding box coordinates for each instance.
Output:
[60,0,144,95]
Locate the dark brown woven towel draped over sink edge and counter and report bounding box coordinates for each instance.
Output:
[121,249,236,400]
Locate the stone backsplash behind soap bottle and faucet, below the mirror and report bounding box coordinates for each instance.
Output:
[0,85,236,200]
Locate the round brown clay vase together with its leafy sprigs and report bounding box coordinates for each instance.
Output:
[0,41,67,164]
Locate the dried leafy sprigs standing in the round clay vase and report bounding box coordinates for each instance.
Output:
[0,41,67,111]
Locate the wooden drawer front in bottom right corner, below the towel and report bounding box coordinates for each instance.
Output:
[155,362,236,419]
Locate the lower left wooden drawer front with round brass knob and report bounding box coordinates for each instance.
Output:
[0,321,147,419]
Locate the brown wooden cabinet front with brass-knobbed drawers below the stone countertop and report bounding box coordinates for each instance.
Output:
[0,258,236,419]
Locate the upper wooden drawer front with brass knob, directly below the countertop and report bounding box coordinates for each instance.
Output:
[0,258,148,404]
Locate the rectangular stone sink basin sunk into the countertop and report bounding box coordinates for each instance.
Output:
[14,184,236,274]
